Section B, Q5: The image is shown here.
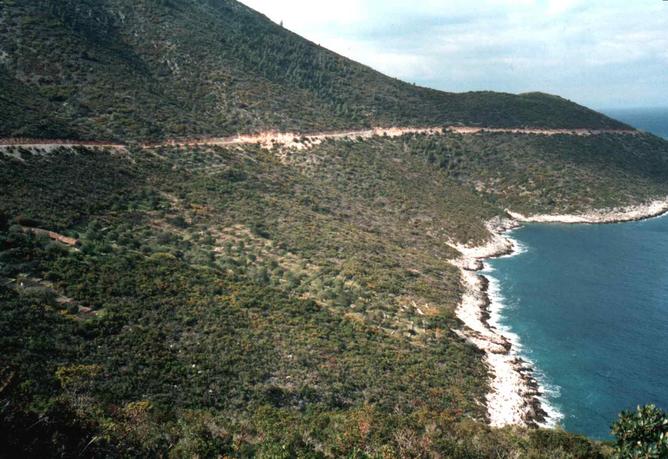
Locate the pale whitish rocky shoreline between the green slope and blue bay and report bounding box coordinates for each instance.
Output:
[451,198,668,427]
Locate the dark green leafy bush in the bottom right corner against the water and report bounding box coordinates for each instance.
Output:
[612,405,668,459]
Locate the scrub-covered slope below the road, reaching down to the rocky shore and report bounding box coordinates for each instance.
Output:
[0,130,668,458]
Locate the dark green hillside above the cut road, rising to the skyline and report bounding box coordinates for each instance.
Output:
[0,0,624,141]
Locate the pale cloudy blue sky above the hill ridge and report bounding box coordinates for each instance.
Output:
[241,0,668,109]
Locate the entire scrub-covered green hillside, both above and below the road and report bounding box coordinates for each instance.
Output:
[0,0,668,459]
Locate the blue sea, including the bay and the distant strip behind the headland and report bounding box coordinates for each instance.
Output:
[484,109,668,439]
